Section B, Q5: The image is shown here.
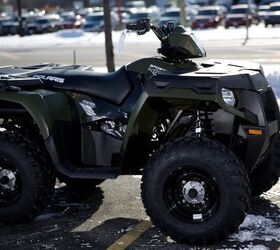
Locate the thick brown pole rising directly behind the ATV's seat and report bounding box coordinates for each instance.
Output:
[103,0,115,72]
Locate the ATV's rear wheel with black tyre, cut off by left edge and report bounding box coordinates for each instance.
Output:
[0,131,55,223]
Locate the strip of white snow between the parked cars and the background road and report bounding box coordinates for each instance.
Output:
[0,25,280,49]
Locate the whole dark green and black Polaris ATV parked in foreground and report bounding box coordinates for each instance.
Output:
[0,19,280,244]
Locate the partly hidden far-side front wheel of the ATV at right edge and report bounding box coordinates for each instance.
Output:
[249,139,280,198]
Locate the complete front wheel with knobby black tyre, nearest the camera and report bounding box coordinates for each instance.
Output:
[142,138,250,244]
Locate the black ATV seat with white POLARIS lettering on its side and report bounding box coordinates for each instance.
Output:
[33,67,132,104]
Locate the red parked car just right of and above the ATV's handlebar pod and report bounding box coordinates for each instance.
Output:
[192,6,226,29]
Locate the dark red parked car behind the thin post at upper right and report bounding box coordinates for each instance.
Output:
[225,4,259,28]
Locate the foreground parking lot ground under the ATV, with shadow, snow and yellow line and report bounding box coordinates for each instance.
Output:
[0,176,280,250]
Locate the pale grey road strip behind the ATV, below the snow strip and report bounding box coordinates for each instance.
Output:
[0,39,280,67]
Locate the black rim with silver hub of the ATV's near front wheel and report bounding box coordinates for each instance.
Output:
[163,166,220,223]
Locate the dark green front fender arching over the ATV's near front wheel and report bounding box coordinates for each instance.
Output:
[124,88,246,151]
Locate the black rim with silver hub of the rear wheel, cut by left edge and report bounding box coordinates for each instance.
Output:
[0,155,21,207]
